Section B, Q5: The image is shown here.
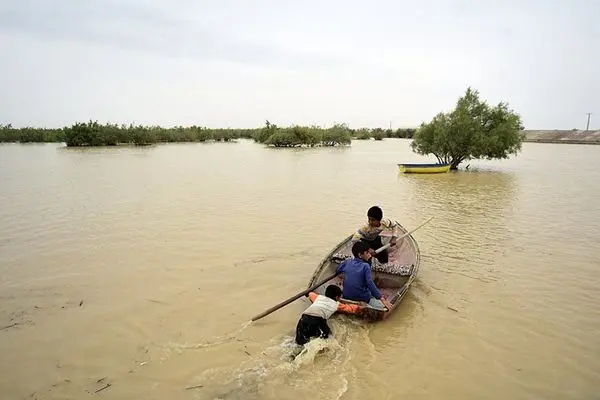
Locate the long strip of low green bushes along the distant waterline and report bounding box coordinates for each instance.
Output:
[0,121,414,147]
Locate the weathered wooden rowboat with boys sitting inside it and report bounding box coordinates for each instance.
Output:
[308,226,421,321]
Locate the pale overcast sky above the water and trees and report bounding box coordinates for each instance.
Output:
[0,0,600,129]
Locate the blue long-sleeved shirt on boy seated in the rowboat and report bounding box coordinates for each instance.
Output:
[336,258,381,303]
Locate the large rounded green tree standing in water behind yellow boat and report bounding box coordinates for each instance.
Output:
[411,87,523,169]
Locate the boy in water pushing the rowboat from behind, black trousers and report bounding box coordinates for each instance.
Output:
[296,285,364,346]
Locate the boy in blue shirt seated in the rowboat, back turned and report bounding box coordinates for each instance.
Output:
[336,241,391,310]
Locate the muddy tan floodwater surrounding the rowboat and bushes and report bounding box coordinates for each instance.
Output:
[0,140,600,399]
